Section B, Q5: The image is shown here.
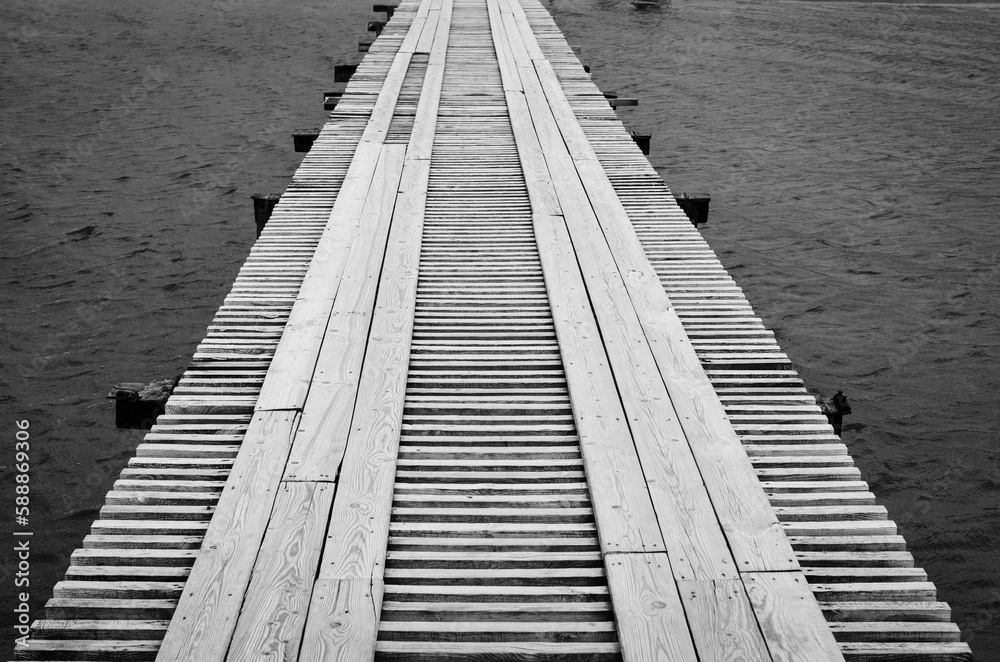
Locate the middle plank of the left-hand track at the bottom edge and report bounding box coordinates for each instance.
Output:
[226,482,334,662]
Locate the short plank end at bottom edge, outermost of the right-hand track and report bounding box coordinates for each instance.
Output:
[740,572,844,662]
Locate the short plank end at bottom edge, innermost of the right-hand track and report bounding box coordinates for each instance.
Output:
[604,554,698,662]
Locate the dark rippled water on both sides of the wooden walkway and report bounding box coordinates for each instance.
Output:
[0,0,1000,661]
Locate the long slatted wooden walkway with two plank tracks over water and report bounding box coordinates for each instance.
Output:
[16,0,971,662]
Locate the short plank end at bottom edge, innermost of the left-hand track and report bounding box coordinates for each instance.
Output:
[298,578,384,662]
